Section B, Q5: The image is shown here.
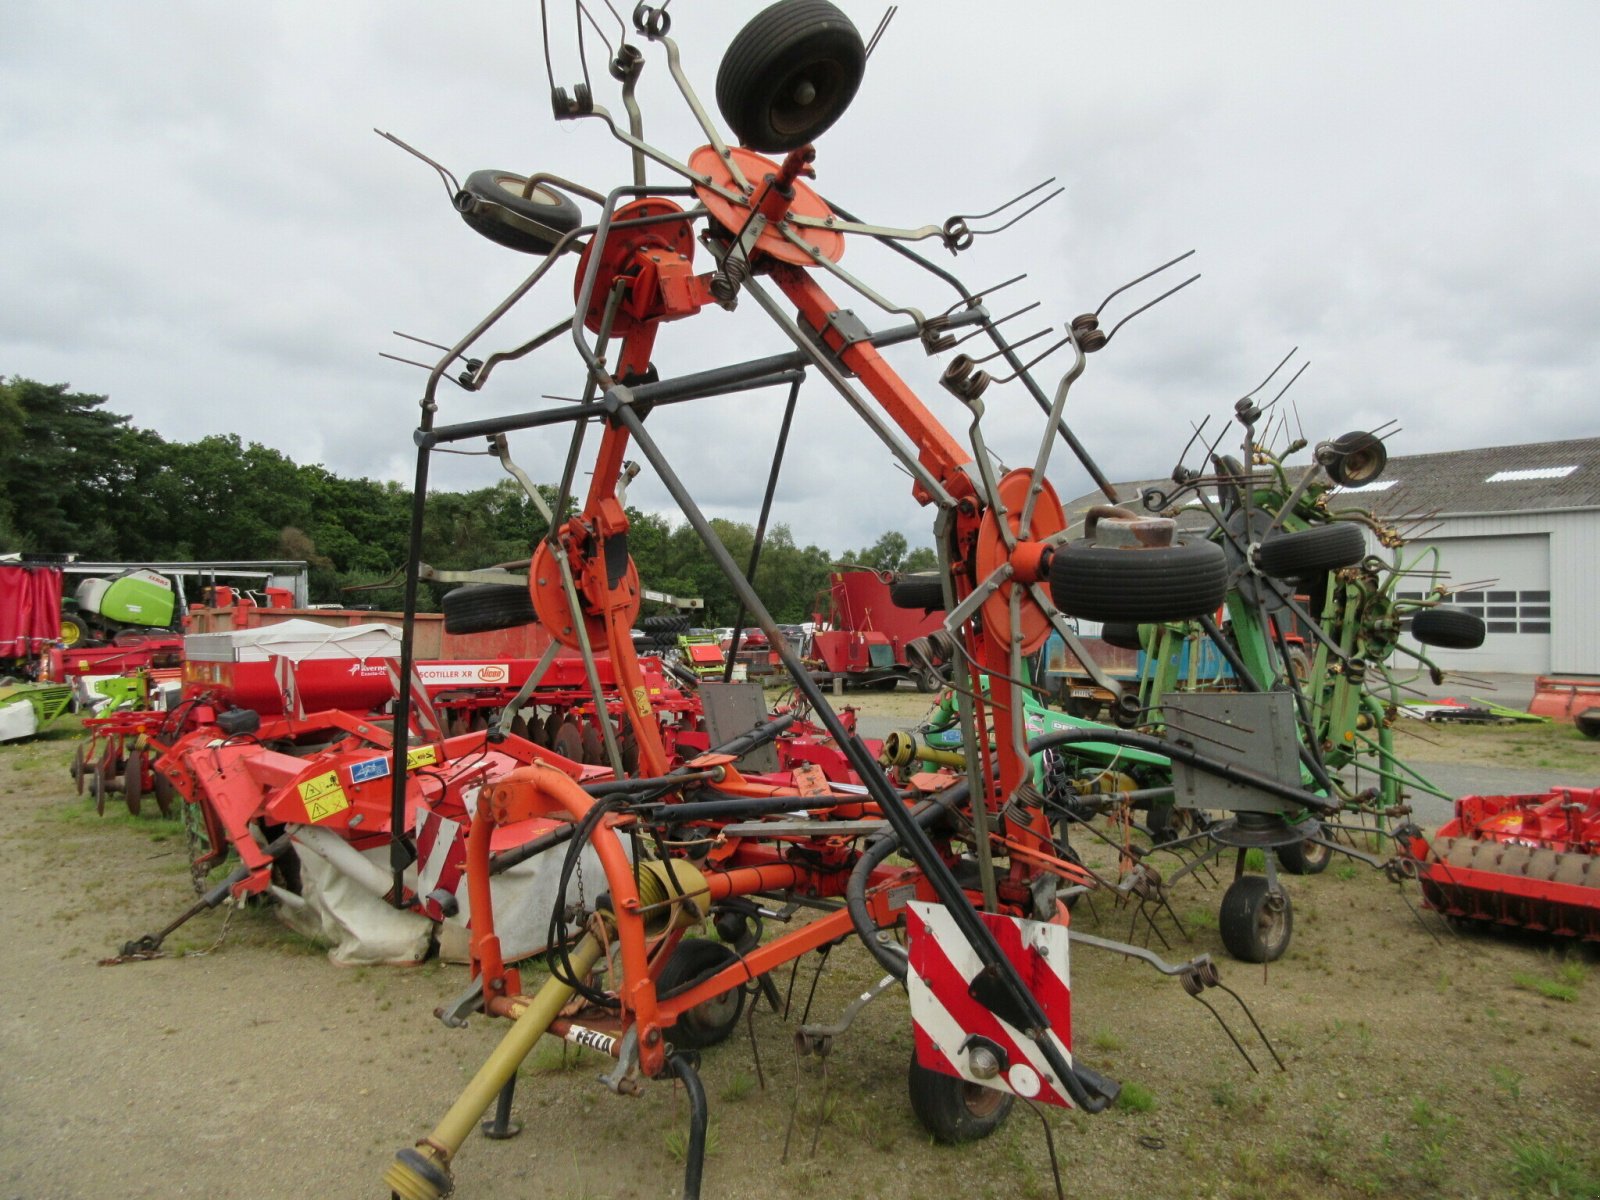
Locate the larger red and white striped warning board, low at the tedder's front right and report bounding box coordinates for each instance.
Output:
[906,901,1072,1107]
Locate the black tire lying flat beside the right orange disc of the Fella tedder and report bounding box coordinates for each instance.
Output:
[1050,541,1227,624]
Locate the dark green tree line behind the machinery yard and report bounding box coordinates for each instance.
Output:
[0,376,936,624]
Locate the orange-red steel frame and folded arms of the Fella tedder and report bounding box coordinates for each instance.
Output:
[467,143,1083,1077]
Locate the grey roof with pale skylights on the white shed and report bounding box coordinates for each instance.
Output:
[1066,437,1600,528]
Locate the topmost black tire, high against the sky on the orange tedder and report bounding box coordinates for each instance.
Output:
[717,0,867,154]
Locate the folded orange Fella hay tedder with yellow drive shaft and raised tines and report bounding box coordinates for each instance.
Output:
[384,0,1315,1200]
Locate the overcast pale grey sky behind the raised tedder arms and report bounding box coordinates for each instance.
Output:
[0,0,1600,550]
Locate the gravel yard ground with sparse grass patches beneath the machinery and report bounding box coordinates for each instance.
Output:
[0,704,1600,1200]
